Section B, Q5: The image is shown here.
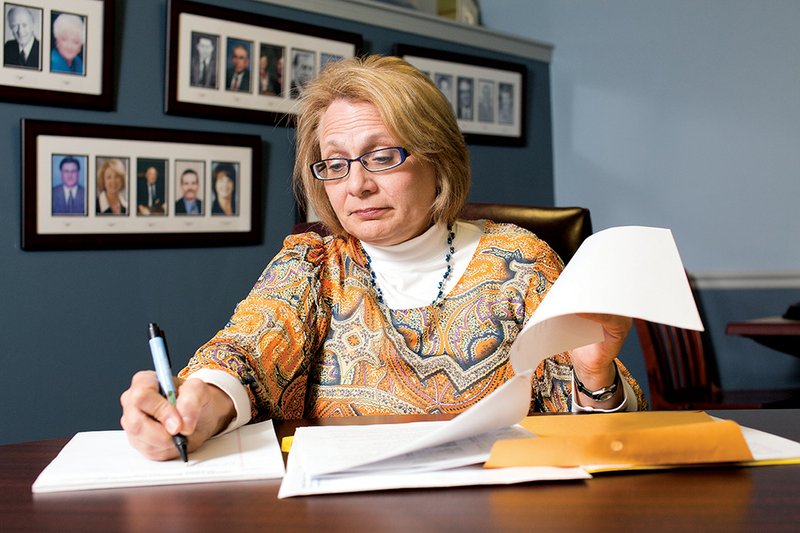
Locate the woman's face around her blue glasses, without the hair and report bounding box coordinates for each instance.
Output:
[319,100,436,246]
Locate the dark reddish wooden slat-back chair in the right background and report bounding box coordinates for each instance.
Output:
[634,319,800,410]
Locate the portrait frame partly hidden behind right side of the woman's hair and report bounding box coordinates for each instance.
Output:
[394,44,527,146]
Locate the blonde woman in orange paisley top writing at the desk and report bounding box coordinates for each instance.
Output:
[121,56,645,459]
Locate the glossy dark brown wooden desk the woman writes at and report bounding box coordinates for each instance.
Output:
[0,410,800,533]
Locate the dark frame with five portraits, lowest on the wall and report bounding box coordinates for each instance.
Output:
[22,119,262,250]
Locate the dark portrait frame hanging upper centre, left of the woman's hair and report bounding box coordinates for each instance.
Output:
[165,0,362,126]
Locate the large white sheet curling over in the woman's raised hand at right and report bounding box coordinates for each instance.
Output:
[510,226,703,371]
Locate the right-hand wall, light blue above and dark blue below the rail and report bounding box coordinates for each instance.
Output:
[481,0,800,400]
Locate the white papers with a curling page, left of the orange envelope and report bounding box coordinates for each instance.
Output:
[278,372,589,498]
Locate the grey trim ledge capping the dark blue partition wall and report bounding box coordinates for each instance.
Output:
[255,0,553,63]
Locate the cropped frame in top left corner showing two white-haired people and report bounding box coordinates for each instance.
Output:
[0,0,115,111]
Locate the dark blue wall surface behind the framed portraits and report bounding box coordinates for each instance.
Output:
[0,0,554,443]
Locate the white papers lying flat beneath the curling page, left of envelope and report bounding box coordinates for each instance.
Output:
[278,422,591,498]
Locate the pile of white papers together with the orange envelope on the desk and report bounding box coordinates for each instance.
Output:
[278,412,800,498]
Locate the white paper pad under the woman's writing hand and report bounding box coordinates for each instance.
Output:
[32,421,284,493]
